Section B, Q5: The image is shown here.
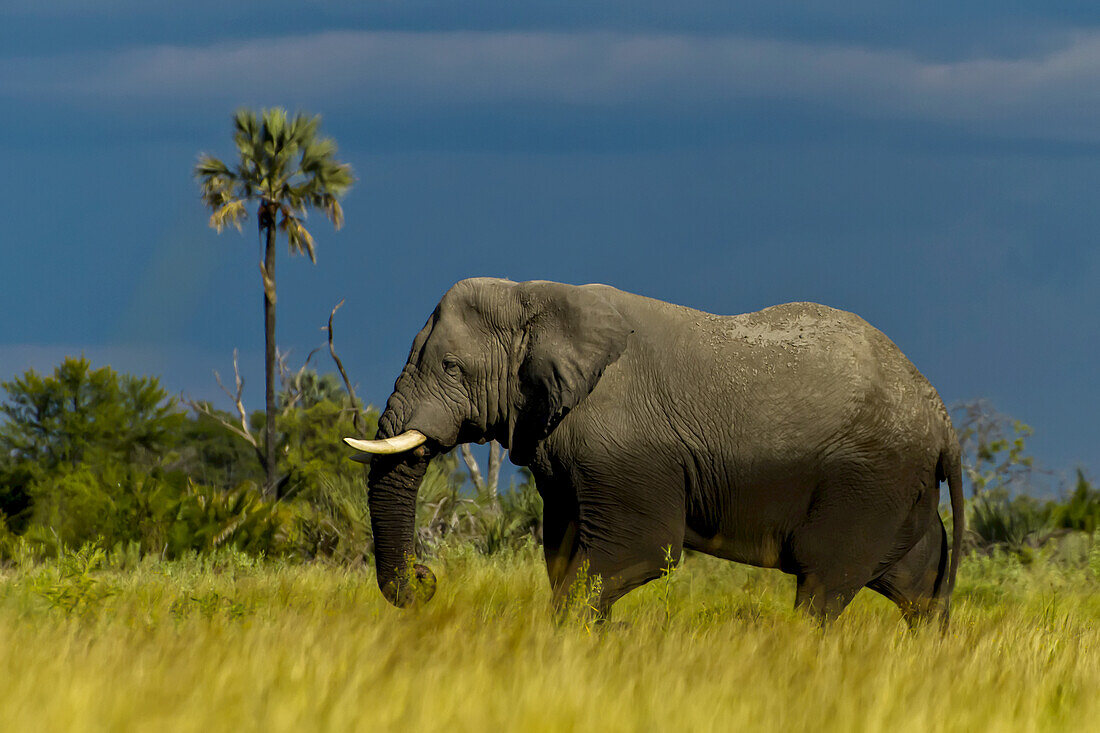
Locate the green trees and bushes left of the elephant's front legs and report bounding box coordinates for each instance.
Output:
[0,358,541,561]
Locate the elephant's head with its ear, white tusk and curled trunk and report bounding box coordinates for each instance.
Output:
[347,278,631,606]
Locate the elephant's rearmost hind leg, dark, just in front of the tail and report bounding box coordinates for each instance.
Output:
[867,515,948,628]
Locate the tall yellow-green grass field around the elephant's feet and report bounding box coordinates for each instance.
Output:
[0,537,1100,733]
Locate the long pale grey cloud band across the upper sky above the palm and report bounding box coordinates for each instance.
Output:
[0,31,1100,141]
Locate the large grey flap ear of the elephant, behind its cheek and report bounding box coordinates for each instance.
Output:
[512,282,633,459]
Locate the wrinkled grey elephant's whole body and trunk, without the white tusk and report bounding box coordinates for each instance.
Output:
[369,278,963,623]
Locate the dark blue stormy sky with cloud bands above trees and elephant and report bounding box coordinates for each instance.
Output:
[0,0,1100,488]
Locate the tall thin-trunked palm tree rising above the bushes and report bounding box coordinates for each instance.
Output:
[195,108,354,494]
